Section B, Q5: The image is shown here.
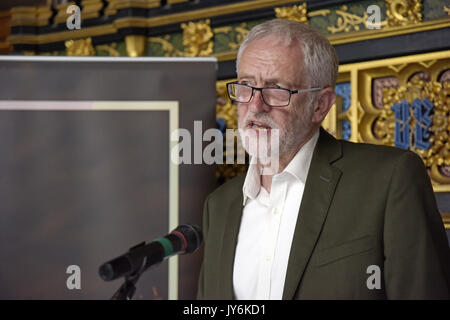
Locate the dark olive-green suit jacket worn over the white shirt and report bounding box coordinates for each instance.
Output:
[198,129,450,299]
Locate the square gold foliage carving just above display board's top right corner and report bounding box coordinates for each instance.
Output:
[181,19,214,57]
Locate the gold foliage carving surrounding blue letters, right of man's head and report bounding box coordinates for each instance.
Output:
[378,77,450,183]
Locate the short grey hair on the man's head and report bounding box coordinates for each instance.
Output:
[236,19,339,88]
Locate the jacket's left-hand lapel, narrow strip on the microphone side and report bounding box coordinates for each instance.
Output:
[218,185,244,300]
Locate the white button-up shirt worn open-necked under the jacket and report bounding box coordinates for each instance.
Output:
[233,130,319,300]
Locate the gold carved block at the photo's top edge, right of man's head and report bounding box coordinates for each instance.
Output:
[386,0,422,27]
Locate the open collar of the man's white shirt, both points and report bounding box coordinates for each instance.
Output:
[242,130,320,206]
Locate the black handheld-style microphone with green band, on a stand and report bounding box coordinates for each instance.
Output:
[99,224,203,281]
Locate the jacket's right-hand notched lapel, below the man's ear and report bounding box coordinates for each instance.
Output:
[283,128,342,300]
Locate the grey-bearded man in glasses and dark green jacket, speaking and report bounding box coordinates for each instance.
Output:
[198,20,450,299]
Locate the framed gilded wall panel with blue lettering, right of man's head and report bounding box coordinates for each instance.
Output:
[336,51,450,192]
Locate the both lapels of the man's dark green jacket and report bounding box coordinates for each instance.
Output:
[219,128,342,299]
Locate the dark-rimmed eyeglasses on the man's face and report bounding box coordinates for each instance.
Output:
[227,81,323,107]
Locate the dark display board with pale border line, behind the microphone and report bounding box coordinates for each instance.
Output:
[0,57,217,299]
